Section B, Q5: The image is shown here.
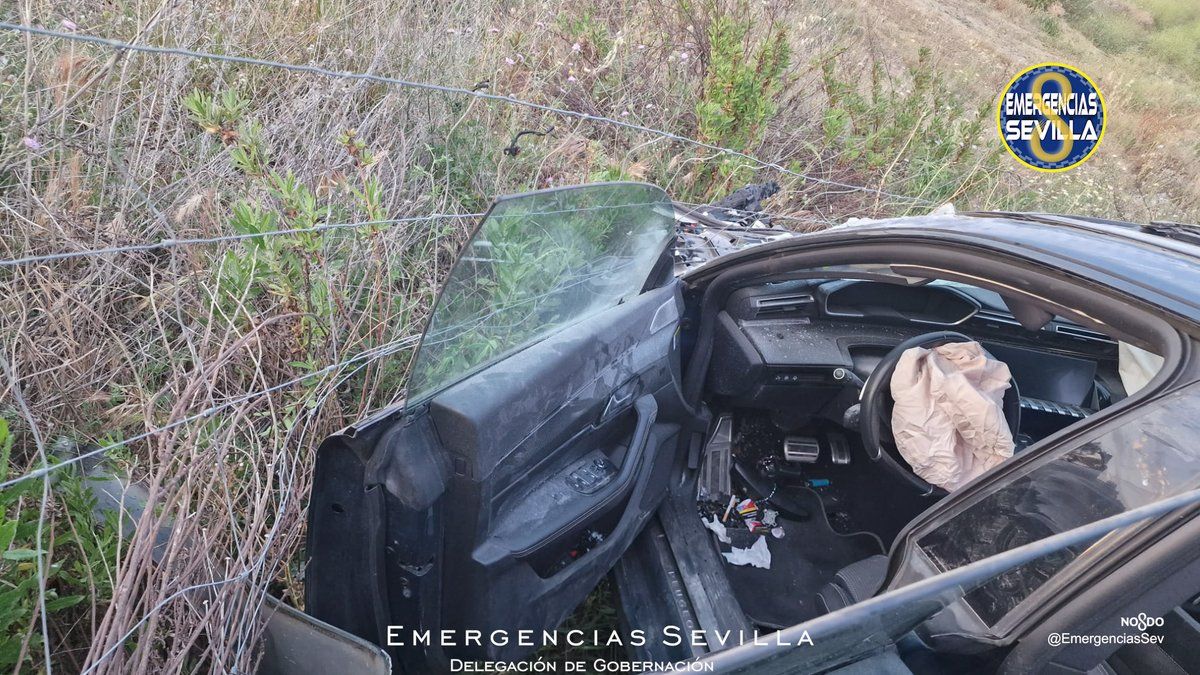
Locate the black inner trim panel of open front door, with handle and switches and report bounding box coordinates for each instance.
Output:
[430,282,682,658]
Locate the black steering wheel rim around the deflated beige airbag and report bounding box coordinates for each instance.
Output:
[858,330,1021,495]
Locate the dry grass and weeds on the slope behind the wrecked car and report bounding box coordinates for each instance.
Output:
[0,0,1195,673]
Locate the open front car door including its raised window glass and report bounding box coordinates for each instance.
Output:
[306,184,691,673]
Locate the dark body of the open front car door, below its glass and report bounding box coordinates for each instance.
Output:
[307,281,689,670]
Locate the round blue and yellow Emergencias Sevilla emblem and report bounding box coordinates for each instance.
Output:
[996,64,1106,172]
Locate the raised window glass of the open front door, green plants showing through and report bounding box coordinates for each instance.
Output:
[408,183,674,402]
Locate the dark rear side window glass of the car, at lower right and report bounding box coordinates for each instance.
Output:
[918,384,1200,626]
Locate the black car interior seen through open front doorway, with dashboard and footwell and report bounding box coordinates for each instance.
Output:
[696,267,1156,631]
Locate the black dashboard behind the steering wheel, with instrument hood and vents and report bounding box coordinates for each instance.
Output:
[709,279,1124,418]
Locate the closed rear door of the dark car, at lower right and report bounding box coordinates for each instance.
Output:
[887,382,1200,673]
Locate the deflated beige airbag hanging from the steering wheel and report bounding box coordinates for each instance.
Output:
[892,342,1013,490]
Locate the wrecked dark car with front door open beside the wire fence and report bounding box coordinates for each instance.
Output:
[295,183,1200,673]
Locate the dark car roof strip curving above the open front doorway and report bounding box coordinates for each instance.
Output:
[682,213,1200,323]
